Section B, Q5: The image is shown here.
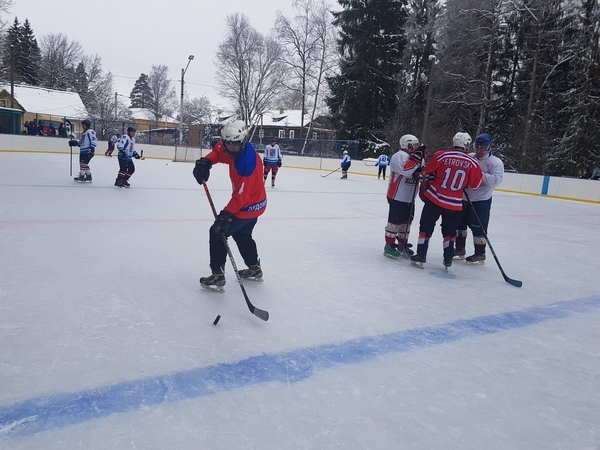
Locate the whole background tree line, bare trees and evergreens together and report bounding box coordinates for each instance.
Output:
[0,0,600,175]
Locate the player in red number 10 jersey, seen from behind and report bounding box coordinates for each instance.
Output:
[410,133,483,270]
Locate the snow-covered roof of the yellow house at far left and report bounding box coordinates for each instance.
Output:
[0,84,88,119]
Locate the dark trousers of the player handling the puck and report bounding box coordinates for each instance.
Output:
[209,217,258,273]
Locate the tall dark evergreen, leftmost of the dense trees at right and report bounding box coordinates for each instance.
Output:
[326,0,407,154]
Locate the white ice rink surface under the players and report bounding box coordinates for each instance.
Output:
[0,151,600,450]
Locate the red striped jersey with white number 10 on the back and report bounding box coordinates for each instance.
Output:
[423,150,483,211]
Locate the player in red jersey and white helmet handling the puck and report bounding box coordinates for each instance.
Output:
[194,120,267,291]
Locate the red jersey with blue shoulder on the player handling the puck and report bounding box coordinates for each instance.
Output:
[206,141,267,219]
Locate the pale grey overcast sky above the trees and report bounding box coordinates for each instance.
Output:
[3,0,339,111]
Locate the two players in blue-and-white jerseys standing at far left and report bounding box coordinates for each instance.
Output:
[69,119,141,188]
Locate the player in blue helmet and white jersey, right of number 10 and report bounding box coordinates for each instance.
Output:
[455,133,504,264]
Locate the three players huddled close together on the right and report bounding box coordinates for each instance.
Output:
[383,132,504,270]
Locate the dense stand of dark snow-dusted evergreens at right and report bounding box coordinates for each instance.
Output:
[327,0,600,176]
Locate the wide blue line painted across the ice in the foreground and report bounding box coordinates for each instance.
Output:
[0,296,600,438]
